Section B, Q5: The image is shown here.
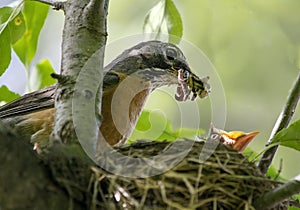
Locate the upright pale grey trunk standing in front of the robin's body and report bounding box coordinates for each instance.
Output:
[52,0,108,152]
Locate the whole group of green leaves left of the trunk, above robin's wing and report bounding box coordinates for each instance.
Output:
[0,1,55,102]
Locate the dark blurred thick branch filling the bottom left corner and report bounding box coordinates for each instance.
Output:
[0,120,79,210]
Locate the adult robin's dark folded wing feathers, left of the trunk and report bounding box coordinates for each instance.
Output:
[0,85,56,118]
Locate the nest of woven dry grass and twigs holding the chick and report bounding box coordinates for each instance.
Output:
[82,140,287,209]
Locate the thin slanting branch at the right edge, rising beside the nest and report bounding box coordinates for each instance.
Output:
[258,72,300,174]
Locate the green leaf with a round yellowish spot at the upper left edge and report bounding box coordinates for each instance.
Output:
[0,5,25,76]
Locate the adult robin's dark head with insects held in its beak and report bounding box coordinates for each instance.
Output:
[106,41,210,100]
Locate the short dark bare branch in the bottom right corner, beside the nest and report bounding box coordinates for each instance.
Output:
[254,180,300,210]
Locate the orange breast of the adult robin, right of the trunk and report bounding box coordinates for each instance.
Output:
[99,77,151,145]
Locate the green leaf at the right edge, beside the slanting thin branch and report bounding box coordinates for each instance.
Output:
[272,120,300,151]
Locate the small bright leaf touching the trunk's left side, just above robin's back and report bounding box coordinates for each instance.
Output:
[30,59,56,90]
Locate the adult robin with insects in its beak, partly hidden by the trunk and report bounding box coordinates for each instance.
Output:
[0,41,210,148]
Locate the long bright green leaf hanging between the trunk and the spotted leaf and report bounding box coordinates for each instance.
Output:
[13,1,49,67]
